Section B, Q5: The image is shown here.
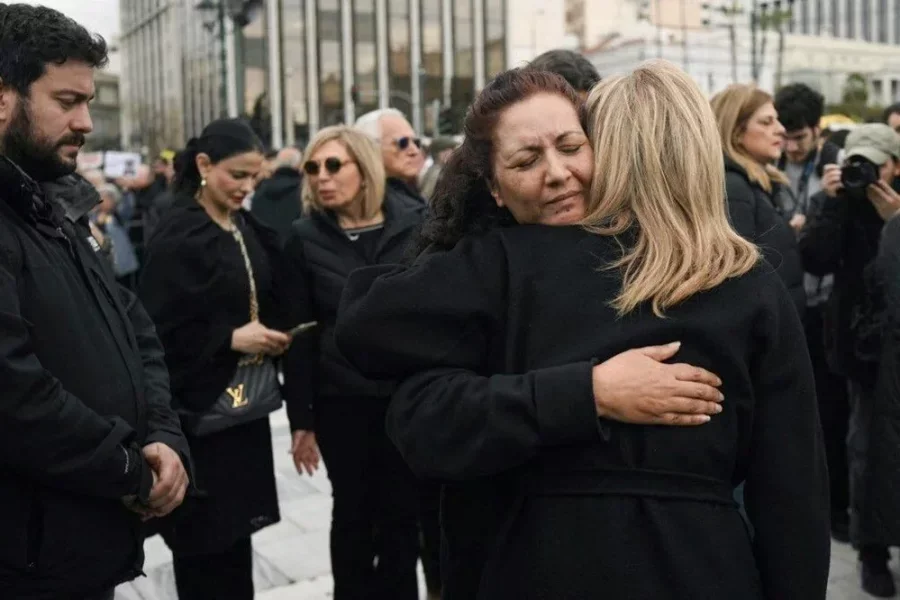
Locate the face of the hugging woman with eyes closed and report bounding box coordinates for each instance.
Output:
[491,93,594,225]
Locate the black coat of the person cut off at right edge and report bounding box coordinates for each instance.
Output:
[854,218,900,546]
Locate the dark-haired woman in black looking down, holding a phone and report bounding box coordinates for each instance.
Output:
[140,120,318,600]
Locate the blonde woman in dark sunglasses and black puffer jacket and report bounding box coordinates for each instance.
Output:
[285,126,424,600]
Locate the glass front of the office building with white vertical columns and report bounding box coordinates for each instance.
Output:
[236,0,509,146]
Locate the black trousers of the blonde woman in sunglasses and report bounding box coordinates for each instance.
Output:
[316,398,419,600]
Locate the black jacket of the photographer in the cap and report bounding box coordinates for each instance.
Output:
[800,192,884,390]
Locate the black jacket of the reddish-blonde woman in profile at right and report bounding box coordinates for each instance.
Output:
[725,158,806,317]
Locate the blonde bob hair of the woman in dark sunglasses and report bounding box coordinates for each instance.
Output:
[302,125,387,219]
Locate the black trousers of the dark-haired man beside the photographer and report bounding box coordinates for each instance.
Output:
[804,305,850,519]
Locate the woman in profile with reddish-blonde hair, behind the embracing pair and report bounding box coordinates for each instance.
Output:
[711,84,806,316]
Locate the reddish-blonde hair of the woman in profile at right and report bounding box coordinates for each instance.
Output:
[710,83,788,192]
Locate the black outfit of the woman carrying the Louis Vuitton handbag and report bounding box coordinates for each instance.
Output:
[140,198,290,555]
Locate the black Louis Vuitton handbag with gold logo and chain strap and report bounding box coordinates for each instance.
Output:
[180,226,282,437]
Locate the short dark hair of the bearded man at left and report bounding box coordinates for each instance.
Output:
[0,3,108,96]
